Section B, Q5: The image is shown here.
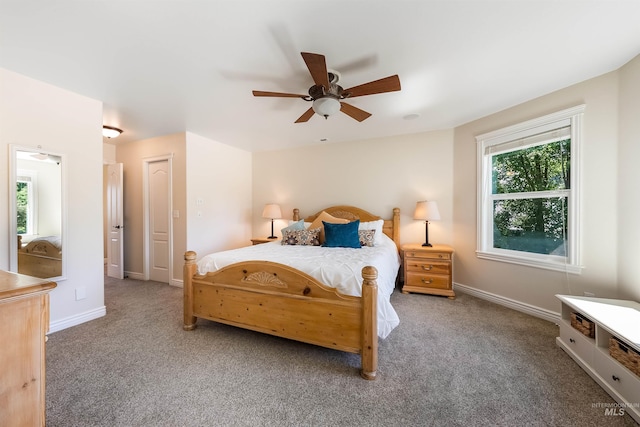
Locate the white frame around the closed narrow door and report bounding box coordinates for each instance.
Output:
[142,153,173,285]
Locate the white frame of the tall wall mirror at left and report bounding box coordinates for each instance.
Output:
[9,144,69,282]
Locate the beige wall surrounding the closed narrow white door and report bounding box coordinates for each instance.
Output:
[116,133,187,280]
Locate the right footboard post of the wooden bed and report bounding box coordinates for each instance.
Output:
[360,266,378,380]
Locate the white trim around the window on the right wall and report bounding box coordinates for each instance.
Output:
[476,105,585,274]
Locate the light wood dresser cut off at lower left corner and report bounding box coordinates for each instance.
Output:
[0,270,56,426]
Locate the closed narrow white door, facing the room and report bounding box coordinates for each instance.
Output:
[148,160,170,283]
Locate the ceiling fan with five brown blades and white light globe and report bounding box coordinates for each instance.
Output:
[253,52,400,123]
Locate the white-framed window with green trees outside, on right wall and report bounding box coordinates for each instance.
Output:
[476,106,584,273]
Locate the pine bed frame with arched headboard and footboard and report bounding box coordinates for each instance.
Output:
[183,206,400,380]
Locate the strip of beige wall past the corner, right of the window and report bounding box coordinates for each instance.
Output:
[617,55,640,301]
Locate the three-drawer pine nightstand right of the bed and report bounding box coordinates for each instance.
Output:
[400,243,456,299]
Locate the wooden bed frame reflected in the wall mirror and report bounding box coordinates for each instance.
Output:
[18,235,62,279]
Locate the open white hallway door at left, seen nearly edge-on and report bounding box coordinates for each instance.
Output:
[107,163,124,279]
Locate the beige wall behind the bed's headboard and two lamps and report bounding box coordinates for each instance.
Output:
[251,129,454,244]
